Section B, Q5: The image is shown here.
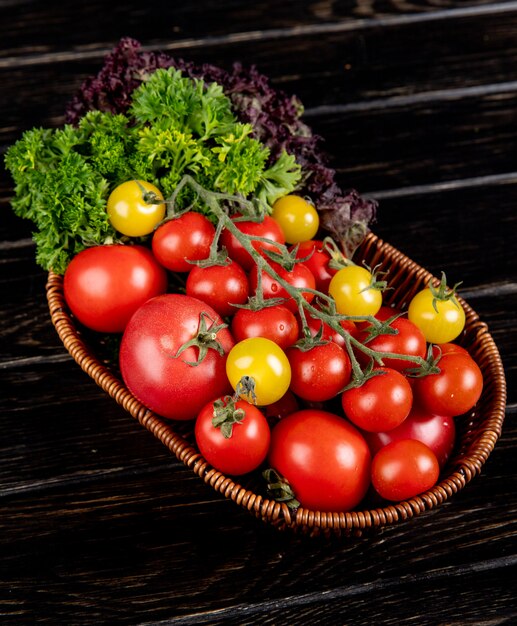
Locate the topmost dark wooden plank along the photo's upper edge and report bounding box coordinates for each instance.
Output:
[0,0,512,58]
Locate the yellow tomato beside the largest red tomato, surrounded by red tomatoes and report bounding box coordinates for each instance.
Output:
[226,337,291,406]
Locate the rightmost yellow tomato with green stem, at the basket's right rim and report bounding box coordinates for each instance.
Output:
[408,287,465,343]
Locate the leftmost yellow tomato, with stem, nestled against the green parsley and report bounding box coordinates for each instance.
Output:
[107,180,165,237]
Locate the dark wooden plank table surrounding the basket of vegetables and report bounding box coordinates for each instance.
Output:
[0,0,517,625]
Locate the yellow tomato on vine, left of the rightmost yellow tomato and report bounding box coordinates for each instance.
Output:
[329,265,382,316]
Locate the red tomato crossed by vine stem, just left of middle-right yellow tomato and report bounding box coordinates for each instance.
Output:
[250,261,316,312]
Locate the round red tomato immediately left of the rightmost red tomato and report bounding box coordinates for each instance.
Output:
[341,367,413,432]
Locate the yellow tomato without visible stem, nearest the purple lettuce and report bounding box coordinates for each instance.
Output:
[271,195,320,243]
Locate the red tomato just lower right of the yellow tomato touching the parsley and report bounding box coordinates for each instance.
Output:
[152,211,215,272]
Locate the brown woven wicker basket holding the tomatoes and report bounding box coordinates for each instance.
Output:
[47,233,506,536]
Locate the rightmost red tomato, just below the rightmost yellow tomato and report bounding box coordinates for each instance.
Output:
[413,352,483,417]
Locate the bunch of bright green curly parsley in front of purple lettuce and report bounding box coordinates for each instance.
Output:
[5,68,301,274]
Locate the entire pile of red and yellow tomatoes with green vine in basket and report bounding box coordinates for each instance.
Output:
[64,180,483,511]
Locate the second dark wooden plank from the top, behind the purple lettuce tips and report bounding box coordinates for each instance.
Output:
[0,3,517,146]
